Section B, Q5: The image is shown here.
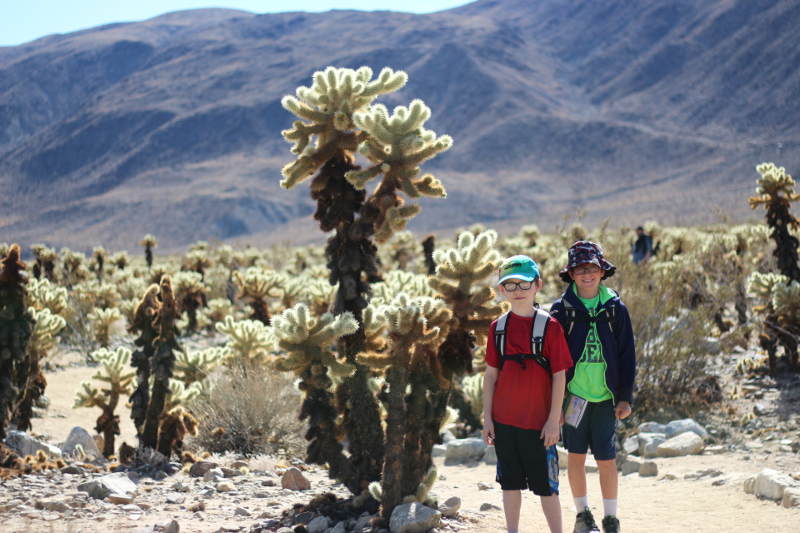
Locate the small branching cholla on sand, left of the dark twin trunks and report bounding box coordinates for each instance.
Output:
[73,347,136,457]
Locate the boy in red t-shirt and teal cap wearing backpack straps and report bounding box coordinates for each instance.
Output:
[483,255,572,533]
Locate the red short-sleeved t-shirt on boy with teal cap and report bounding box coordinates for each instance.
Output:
[486,313,572,430]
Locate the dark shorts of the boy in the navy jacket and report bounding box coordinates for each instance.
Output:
[562,400,617,461]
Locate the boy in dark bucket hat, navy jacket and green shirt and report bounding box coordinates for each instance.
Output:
[550,241,636,533]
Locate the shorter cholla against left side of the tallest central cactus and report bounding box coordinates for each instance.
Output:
[273,304,358,478]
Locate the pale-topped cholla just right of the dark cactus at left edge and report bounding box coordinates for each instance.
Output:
[12,307,66,431]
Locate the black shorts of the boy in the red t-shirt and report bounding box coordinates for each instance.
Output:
[494,422,558,496]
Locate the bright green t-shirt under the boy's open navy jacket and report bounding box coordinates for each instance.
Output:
[567,284,614,402]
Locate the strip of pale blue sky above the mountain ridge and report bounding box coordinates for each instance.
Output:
[0,0,469,46]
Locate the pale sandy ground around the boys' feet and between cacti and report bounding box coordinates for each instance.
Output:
[7,358,800,533]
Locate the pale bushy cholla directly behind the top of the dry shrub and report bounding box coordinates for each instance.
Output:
[217,316,275,372]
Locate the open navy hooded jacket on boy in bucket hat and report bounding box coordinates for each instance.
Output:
[550,284,636,403]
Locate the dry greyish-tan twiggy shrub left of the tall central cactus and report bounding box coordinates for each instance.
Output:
[189,367,306,456]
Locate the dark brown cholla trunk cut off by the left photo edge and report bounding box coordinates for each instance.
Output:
[0,244,35,441]
